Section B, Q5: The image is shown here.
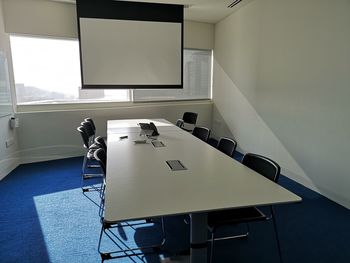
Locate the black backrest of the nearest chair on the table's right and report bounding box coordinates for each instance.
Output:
[242,153,281,183]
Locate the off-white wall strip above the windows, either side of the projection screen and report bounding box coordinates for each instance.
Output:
[3,0,214,49]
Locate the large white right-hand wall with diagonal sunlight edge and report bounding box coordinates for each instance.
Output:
[213,0,350,207]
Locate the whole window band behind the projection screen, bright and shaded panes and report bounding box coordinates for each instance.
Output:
[10,35,212,105]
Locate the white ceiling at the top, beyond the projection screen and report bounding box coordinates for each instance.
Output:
[51,0,252,24]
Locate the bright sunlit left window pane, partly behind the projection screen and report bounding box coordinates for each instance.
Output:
[10,36,129,105]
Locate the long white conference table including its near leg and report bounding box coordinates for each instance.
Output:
[104,119,301,263]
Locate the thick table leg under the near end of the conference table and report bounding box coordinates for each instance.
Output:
[190,213,208,263]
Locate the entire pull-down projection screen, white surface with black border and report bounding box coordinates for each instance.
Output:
[77,1,183,89]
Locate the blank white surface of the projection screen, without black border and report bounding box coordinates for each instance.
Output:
[79,18,182,88]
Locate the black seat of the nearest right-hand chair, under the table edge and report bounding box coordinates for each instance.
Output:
[208,207,267,228]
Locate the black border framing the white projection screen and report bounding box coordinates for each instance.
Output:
[76,0,184,89]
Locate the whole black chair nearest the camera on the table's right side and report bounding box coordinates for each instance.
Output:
[208,153,282,262]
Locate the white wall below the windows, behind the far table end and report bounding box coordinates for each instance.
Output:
[17,102,212,163]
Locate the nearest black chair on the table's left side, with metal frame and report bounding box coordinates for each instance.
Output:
[94,148,165,262]
